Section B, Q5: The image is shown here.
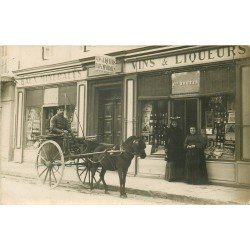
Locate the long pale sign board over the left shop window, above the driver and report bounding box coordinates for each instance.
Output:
[16,70,86,88]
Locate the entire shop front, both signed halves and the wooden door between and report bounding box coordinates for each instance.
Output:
[14,46,250,186]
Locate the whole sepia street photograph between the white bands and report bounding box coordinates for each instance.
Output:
[0,45,250,205]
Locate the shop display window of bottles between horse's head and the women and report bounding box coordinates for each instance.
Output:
[141,100,168,154]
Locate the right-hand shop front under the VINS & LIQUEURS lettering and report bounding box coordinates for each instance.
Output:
[122,46,250,185]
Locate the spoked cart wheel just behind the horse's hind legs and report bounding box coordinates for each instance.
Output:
[75,158,100,189]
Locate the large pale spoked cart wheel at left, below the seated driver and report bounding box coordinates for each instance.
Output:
[36,140,65,188]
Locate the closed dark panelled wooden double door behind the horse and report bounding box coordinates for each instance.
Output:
[98,89,122,144]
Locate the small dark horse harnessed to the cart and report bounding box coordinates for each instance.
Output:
[90,136,146,198]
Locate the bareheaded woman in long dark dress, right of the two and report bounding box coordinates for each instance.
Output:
[184,127,208,184]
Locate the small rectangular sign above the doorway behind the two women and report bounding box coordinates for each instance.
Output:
[172,71,200,95]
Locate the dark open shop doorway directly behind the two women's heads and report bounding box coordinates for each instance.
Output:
[172,99,198,137]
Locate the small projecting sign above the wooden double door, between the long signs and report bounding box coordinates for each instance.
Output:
[95,55,116,74]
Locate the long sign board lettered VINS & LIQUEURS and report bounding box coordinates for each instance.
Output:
[124,46,250,73]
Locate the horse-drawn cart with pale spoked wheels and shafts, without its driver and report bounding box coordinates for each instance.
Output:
[36,134,121,188]
